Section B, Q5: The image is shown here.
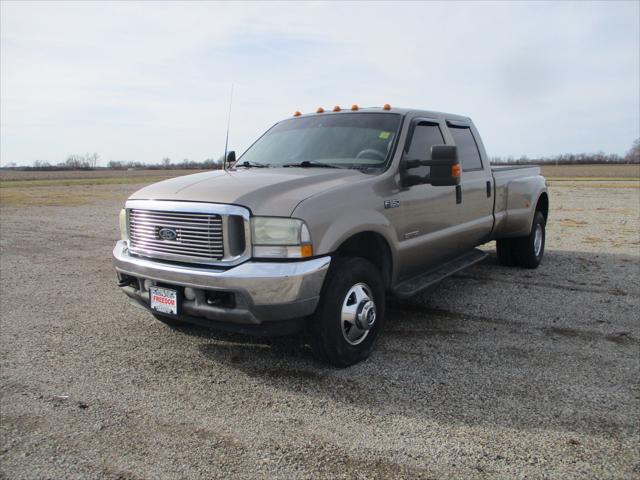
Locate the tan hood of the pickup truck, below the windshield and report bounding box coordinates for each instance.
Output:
[129,168,369,216]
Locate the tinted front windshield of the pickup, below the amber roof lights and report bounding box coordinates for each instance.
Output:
[238,113,401,168]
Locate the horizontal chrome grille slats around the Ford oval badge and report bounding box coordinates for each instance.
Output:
[129,209,225,263]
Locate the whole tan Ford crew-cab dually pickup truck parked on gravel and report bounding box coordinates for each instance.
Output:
[113,105,549,366]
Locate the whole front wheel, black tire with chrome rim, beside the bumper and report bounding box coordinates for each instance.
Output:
[309,257,385,368]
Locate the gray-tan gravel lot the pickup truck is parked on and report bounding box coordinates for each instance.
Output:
[0,181,640,479]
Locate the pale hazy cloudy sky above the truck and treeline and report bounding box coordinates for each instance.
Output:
[0,1,640,165]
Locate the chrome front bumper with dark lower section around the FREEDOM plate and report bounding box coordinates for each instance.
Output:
[113,240,331,326]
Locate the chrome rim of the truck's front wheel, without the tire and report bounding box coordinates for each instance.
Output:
[340,283,376,345]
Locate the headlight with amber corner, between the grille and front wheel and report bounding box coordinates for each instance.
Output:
[251,217,313,258]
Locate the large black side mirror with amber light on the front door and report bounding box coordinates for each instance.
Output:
[401,145,462,187]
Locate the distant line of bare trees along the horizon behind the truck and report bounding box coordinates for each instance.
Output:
[2,138,640,170]
